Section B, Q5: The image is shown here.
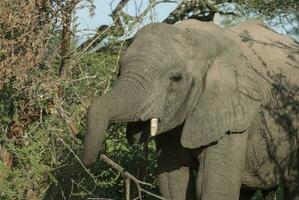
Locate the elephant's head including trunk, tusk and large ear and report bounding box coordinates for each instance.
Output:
[82,23,259,165]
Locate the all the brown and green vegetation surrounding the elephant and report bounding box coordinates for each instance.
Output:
[0,0,298,200]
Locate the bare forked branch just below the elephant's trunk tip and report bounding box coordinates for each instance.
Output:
[100,154,165,200]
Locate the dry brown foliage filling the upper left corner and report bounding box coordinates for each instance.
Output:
[0,0,52,88]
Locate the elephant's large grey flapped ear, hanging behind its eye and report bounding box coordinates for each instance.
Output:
[181,53,260,148]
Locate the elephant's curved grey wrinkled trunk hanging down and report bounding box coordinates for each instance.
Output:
[81,84,143,166]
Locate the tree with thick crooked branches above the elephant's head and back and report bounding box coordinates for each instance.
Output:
[79,0,299,50]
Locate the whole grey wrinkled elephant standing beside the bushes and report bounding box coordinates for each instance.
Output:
[82,20,299,200]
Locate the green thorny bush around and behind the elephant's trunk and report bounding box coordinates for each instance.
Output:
[0,53,157,199]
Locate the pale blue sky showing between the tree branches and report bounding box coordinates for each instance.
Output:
[76,0,299,42]
